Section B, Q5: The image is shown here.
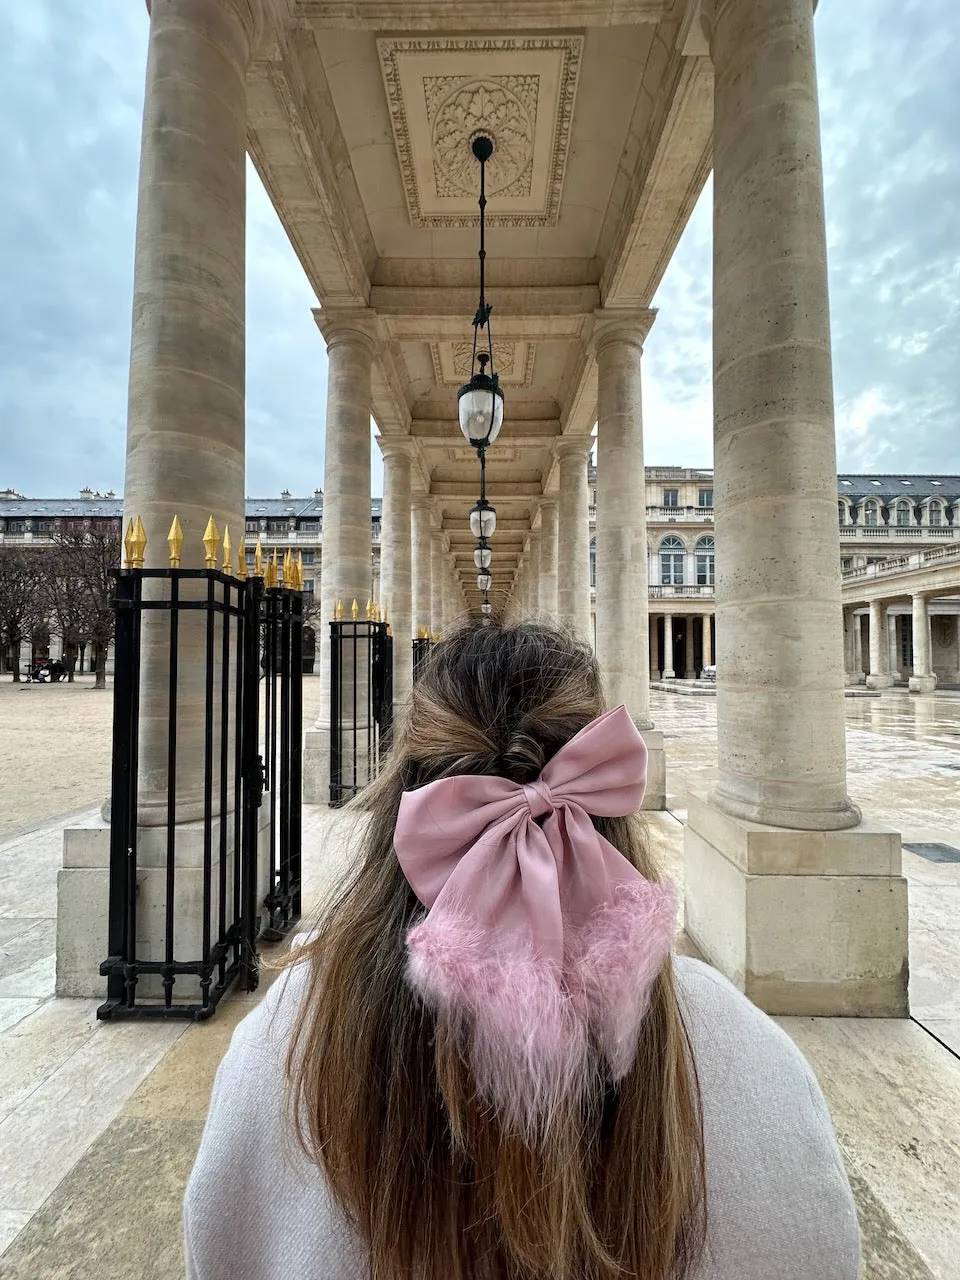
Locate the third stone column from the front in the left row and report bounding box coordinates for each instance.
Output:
[378,435,413,705]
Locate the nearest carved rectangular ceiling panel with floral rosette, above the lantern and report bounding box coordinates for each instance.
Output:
[376,36,584,227]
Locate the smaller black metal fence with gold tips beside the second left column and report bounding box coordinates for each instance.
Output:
[330,618,393,809]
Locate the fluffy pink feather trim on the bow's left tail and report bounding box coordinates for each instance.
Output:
[407,908,598,1140]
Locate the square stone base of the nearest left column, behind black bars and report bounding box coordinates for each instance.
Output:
[56,795,273,1000]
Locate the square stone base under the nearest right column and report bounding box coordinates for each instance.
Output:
[684,794,909,1018]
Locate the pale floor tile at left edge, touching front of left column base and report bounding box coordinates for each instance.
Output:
[0,1000,97,1121]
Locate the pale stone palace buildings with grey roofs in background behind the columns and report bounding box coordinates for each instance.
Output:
[0,465,960,690]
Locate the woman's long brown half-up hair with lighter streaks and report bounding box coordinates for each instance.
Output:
[288,623,705,1280]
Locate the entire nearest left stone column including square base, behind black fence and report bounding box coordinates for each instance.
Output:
[60,0,264,998]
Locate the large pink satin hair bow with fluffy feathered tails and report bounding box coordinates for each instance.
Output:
[394,707,676,1133]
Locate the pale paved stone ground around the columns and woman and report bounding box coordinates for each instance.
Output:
[0,681,960,1280]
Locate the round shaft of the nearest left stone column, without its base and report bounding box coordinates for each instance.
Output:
[124,0,259,826]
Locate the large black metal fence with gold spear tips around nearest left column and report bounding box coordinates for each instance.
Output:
[97,568,302,1019]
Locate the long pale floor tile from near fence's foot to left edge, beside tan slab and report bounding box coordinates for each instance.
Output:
[0,1021,186,1211]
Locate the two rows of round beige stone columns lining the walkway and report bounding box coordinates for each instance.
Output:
[67,0,911,1015]
